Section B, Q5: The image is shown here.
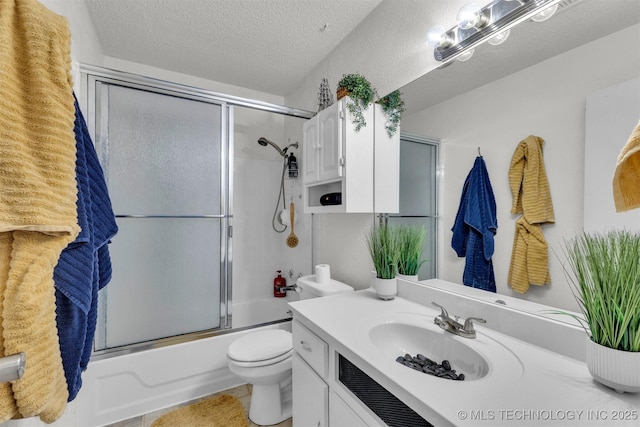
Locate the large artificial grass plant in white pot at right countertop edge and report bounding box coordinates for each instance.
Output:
[565,231,640,392]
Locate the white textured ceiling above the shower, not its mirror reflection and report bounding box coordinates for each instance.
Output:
[86,0,381,96]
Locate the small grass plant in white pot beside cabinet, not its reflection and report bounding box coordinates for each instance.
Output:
[366,224,400,300]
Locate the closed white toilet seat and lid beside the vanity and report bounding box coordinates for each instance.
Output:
[227,329,293,367]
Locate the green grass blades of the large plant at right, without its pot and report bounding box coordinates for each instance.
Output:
[565,231,640,352]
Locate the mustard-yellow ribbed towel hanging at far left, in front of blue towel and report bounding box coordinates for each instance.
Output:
[0,0,79,423]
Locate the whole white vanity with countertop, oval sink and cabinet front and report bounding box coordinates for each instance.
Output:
[290,280,640,427]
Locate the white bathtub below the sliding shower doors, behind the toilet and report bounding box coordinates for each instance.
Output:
[75,295,296,427]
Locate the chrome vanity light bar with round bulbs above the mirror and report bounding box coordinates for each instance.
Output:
[427,0,562,62]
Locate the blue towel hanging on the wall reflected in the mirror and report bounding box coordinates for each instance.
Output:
[451,156,498,292]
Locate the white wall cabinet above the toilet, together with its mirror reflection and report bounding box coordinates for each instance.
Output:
[302,98,400,213]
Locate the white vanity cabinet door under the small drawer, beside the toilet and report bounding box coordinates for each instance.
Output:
[293,353,329,427]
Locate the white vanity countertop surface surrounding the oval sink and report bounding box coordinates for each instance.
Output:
[290,290,640,426]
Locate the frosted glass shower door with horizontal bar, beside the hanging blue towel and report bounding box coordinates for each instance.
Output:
[95,82,228,350]
